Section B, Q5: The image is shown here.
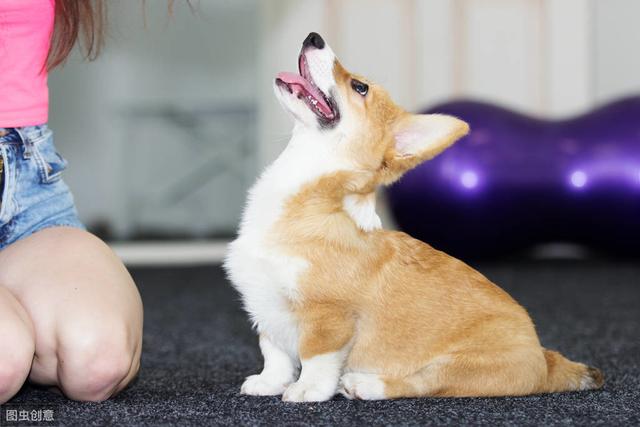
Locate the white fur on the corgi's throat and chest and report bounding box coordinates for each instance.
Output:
[225,132,356,357]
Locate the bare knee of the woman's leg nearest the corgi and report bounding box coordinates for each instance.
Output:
[58,334,137,402]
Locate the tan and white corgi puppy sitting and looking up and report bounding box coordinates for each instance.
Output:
[225,33,603,402]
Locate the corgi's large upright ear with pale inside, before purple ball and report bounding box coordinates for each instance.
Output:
[382,114,469,183]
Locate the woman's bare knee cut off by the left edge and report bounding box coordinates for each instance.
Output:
[0,338,34,404]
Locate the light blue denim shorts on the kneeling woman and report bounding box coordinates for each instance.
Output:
[0,125,84,250]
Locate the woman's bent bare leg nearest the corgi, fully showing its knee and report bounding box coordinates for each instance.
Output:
[0,227,142,401]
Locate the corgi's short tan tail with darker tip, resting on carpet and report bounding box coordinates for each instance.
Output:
[543,349,604,393]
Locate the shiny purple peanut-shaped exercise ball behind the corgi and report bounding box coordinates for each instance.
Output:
[388,97,640,258]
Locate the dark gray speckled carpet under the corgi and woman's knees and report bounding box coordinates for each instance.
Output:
[3,262,640,426]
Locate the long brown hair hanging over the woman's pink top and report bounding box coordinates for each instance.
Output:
[46,0,107,70]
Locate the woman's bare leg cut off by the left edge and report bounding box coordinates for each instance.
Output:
[0,285,35,404]
